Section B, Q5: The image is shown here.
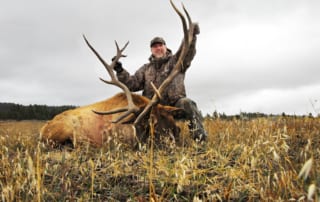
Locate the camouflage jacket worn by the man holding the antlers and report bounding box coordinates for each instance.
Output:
[117,36,196,106]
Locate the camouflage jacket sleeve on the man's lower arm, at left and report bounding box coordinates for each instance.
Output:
[117,65,146,92]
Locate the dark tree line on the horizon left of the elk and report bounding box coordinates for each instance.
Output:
[0,103,76,120]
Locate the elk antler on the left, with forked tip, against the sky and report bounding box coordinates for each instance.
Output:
[83,35,139,123]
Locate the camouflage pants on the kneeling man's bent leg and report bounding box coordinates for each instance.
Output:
[175,98,207,141]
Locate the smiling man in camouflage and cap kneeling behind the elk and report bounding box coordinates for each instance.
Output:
[114,25,207,141]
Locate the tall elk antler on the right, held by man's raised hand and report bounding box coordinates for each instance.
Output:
[134,0,195,124]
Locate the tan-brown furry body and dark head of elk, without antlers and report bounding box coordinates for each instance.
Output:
[40,93,179,146]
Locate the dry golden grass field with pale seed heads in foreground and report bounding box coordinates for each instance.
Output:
[0,117,320,201]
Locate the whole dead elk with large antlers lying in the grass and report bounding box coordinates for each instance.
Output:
[40,1,195,146]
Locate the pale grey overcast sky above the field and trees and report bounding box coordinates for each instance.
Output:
[0,0,320,114]
